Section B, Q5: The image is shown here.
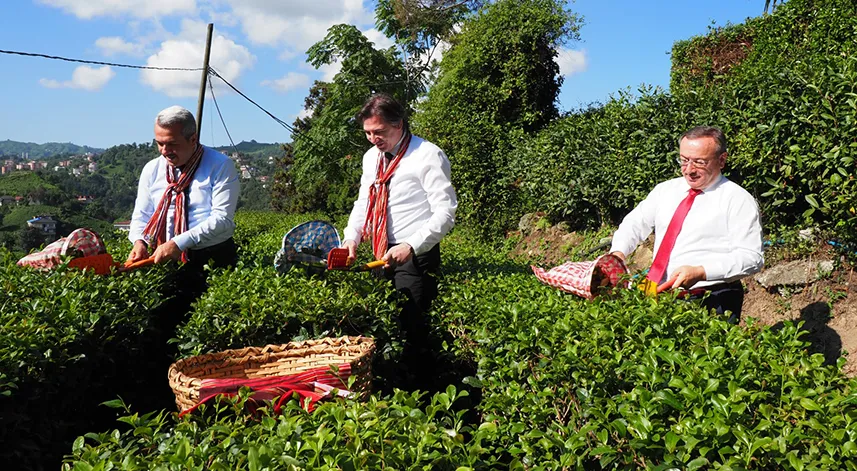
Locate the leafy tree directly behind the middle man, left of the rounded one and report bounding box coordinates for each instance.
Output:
[282,25,424,213]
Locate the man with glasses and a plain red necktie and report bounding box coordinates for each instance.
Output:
[610,126,763,323]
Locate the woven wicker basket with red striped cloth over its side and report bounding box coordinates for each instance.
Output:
[168,337,375,411]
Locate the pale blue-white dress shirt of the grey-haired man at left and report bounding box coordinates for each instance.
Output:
[128,146,241,251]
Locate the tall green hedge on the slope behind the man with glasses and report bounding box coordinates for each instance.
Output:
[504,0,857,241]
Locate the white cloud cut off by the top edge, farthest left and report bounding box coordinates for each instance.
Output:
[37,0,196,19]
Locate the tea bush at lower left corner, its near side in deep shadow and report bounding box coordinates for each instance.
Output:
[0,249,171,470]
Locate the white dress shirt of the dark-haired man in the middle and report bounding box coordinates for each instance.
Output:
[344,136,458,255]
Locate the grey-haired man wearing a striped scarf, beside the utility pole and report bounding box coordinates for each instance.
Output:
[128,106,240,272]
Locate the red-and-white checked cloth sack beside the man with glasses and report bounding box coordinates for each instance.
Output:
[531,254,629,299]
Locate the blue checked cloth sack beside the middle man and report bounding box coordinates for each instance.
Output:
[274,221,340,274]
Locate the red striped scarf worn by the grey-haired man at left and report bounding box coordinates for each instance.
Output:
[143,144,203,262]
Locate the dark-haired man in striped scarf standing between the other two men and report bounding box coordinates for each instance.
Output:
[343,94,458,390]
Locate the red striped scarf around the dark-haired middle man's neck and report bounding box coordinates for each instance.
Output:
[363,131,411,260]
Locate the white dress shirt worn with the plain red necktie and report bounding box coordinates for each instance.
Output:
[610,175,764,288]
